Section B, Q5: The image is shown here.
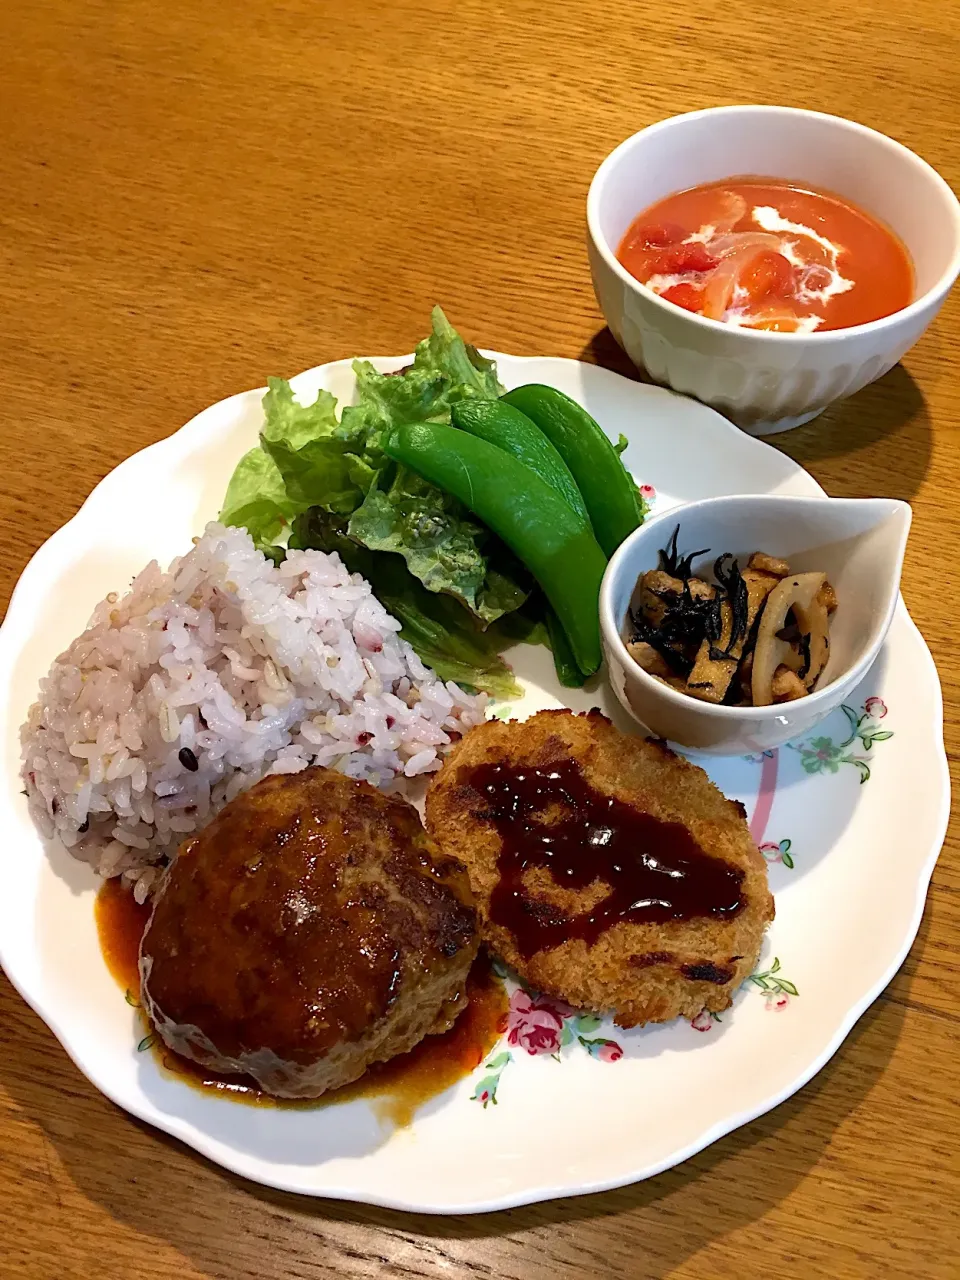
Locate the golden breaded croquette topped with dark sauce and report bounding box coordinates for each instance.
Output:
[426,710,773,1027]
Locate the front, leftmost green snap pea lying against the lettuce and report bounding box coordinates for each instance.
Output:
[384,422,607,676]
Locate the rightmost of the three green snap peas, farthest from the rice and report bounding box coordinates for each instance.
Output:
[502,383,643,556]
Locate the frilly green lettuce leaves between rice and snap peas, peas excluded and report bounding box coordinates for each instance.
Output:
[220,307,534,696]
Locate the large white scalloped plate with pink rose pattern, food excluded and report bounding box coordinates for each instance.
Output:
[0,355,948,1213]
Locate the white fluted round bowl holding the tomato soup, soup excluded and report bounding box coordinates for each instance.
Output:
[586,106,960,435]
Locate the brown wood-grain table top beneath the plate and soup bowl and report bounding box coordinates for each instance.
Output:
[0,0,960,1280]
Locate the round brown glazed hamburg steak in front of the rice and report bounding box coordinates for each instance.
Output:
[140,768,479,1098]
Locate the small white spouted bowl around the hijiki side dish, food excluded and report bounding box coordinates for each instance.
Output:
[600,494,911,755]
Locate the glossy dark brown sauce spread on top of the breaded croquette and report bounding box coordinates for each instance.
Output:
[465,759,745,957]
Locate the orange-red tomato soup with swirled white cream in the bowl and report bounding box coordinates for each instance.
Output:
[617,178,914,333]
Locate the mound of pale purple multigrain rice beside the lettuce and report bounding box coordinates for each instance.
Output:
[20,524,486,901]
